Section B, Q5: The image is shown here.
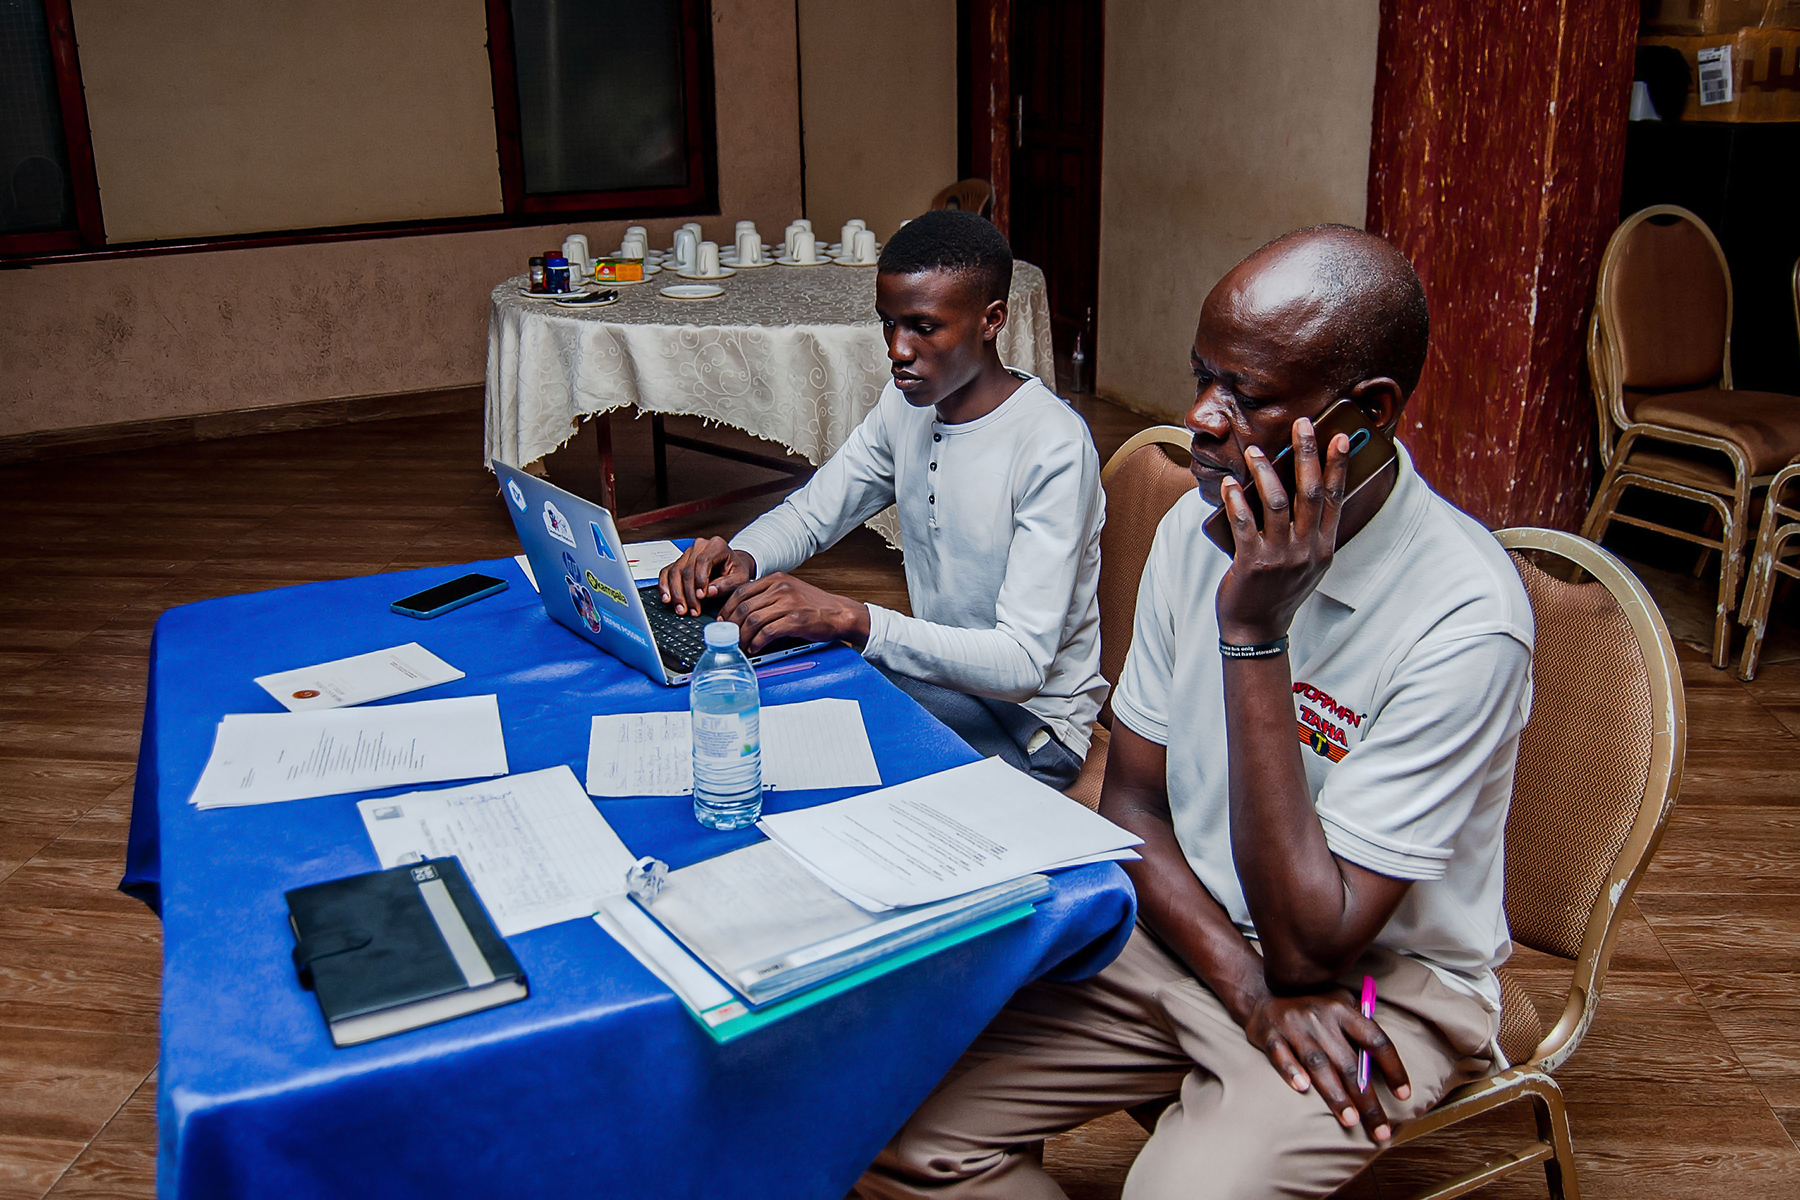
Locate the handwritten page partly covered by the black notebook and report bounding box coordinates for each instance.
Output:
[356,766,635,937]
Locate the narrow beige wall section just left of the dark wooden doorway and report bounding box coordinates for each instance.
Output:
[799,0,956,241]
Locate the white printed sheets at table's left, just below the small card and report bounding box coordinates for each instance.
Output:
[187,696,506,808]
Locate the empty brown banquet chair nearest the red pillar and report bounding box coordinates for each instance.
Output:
[1582,205,1800,667]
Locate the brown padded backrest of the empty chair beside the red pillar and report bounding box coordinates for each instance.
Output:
[1595,205,1732,421]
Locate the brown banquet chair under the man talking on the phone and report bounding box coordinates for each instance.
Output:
[1324,529,1687,1200]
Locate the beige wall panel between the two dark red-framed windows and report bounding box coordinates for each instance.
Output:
[74,0,500,241]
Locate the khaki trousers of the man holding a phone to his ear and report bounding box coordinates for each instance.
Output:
[857,927,1498,1200]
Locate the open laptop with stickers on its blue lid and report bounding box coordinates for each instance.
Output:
[493,462,830,687]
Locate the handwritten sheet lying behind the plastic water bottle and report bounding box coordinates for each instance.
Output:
[587,698,882,795]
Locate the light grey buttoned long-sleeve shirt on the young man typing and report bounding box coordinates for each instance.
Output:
[731,372,1107,754]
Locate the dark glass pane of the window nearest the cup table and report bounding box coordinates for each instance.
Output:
[511,0,688,196]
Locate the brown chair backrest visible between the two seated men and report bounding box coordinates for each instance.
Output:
[1100,425,1195,729]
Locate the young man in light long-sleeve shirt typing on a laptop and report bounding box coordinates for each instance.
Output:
[661,210,1107,788]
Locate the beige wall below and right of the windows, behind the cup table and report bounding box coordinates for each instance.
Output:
[0,0,799,440]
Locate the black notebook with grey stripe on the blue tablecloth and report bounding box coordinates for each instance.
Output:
[288,858,529,1045]
